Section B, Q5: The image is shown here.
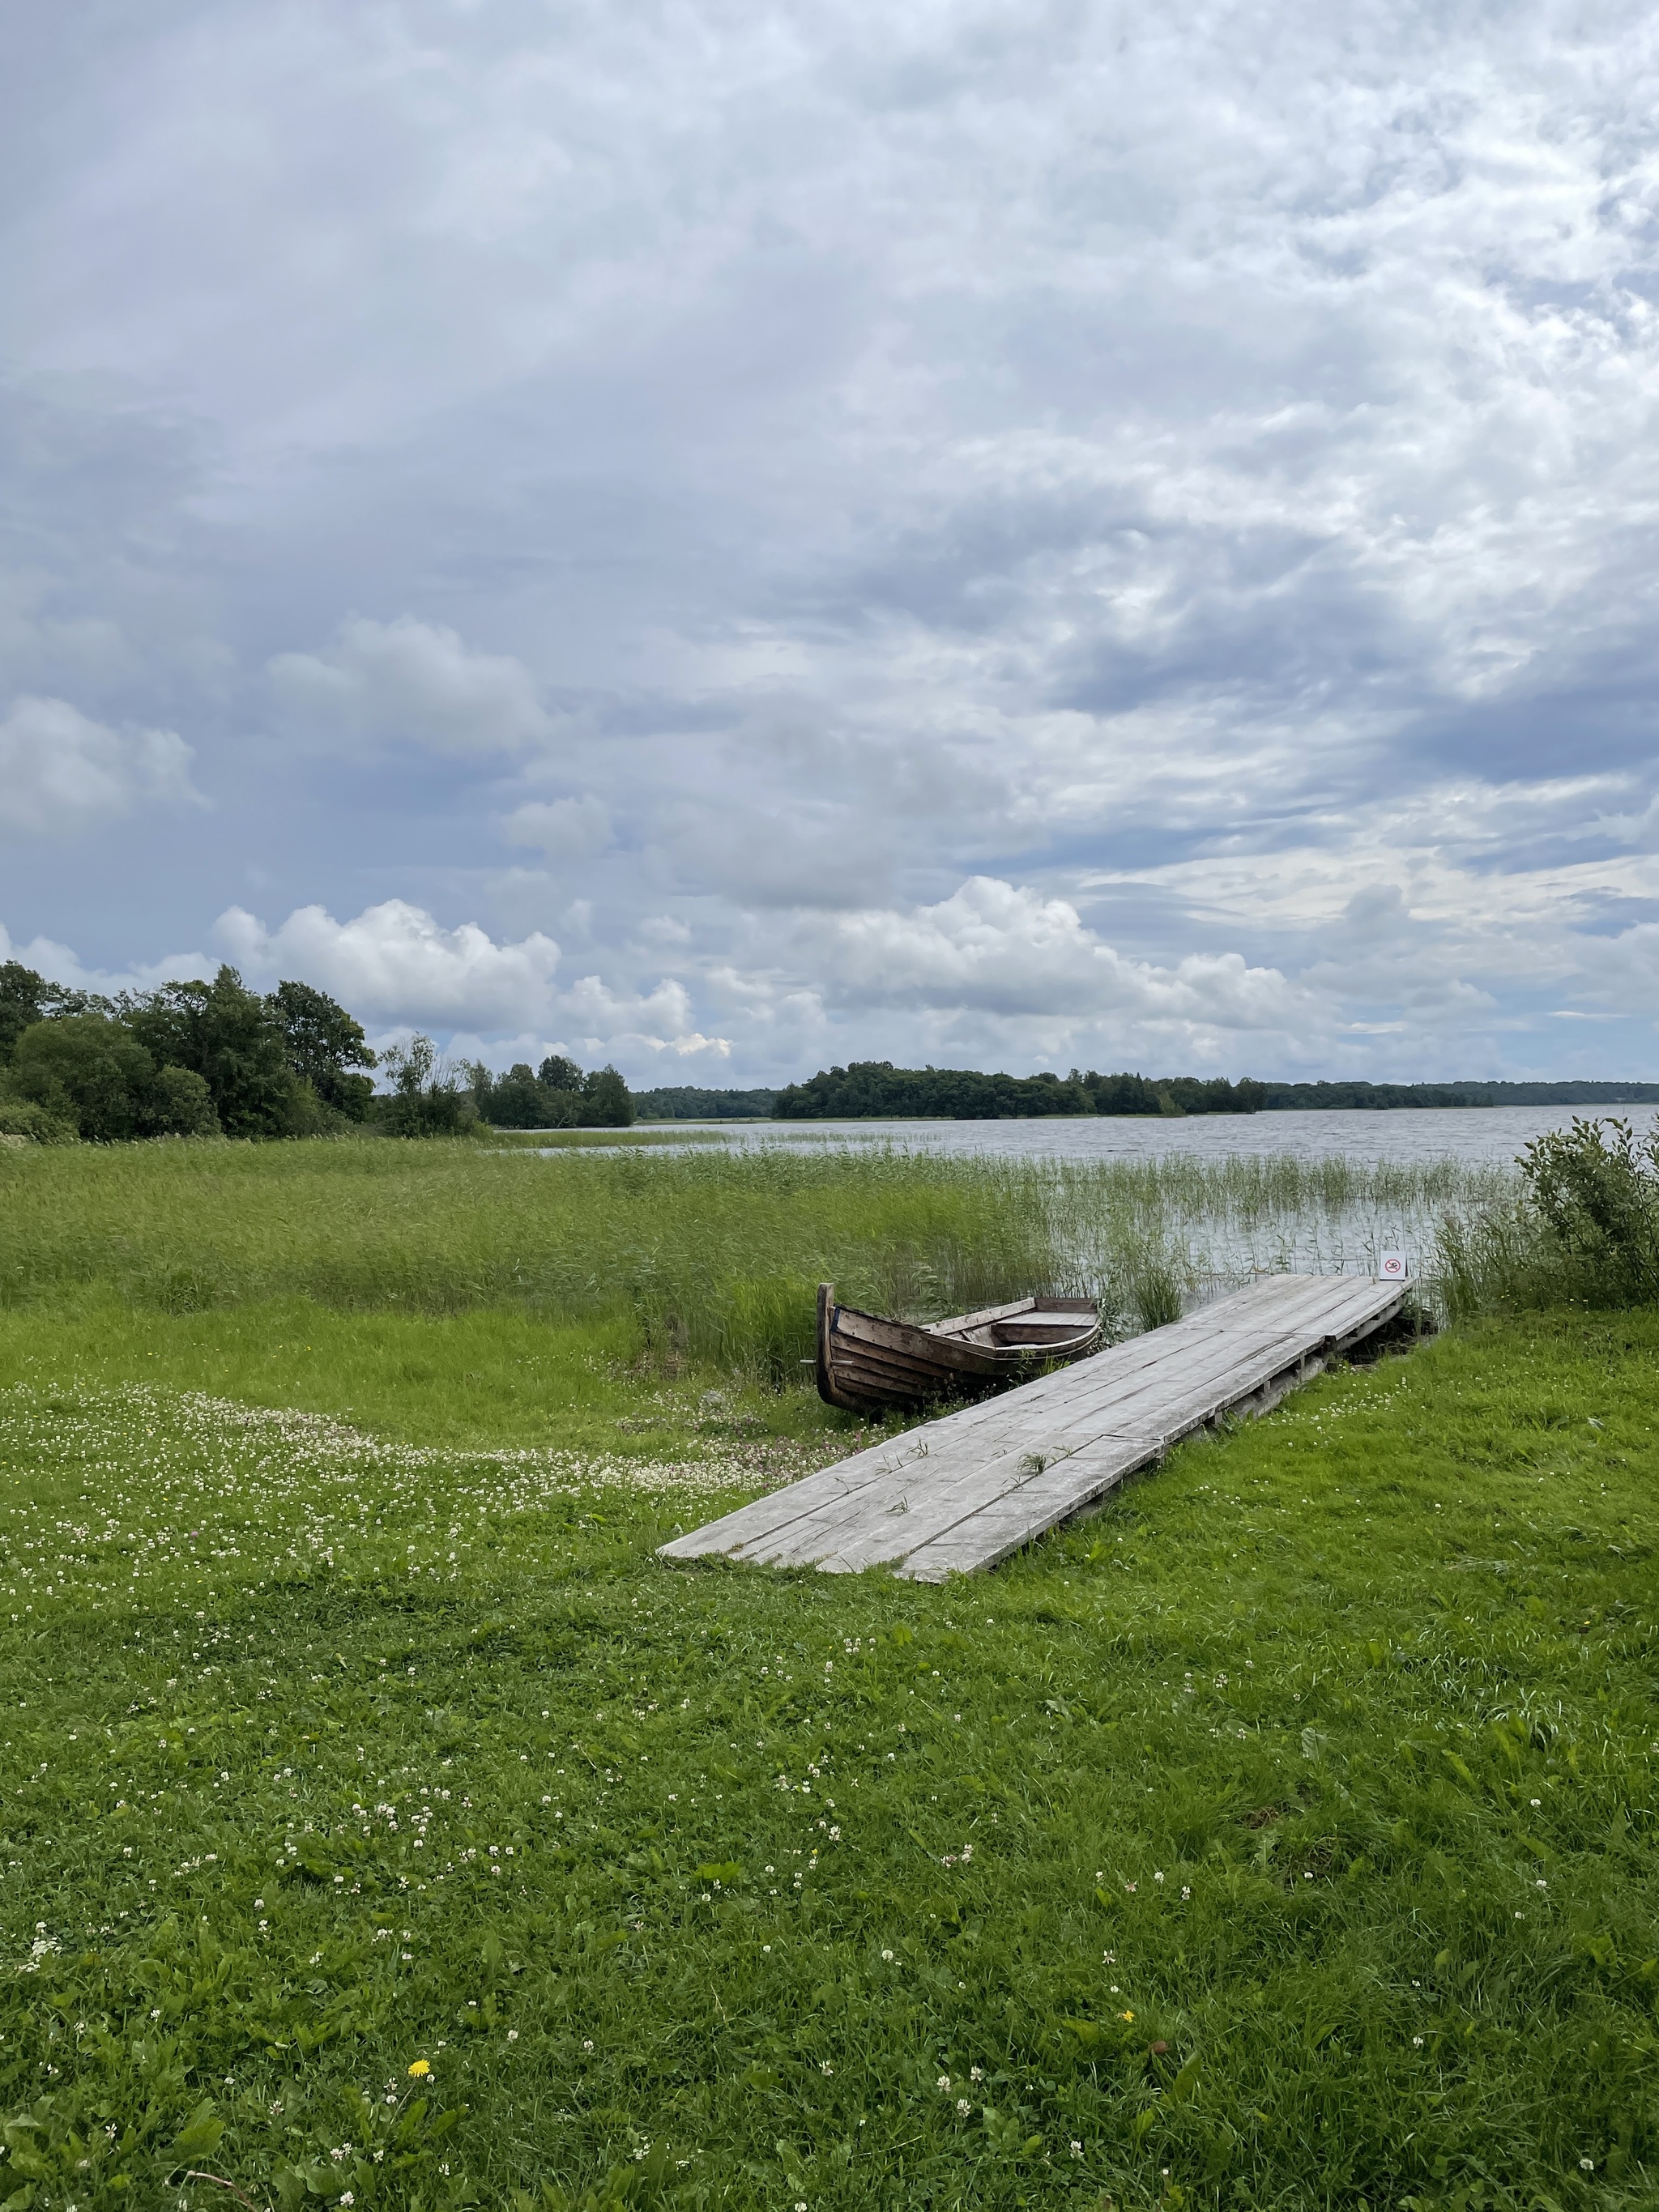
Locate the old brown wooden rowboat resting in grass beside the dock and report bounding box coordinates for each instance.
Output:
[818,1283,1099,1413]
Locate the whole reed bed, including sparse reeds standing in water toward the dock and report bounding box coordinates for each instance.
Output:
[0,1141,1511,1385]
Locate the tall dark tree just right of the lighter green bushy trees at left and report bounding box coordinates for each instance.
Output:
[122,966,305,1137]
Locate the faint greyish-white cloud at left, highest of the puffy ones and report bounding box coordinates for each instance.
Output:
[266,615,553,754]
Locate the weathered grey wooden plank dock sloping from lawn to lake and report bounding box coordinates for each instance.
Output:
[659,1274,1405,1582]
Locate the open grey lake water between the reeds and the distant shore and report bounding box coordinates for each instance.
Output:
[653,1106,1627,1166]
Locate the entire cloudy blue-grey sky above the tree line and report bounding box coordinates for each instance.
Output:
[0,0,1659,1086]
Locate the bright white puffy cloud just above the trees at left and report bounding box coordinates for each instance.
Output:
[217,898,560,1031]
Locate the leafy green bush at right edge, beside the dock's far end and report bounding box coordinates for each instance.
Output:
[1438,1119,1659,1319]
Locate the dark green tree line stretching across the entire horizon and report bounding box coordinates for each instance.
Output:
[0,960,1659,1144]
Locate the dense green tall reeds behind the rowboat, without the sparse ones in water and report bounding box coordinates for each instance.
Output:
[0,1141,1071,1380]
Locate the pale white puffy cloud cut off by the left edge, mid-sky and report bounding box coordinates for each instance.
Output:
[0,695,201,836]
